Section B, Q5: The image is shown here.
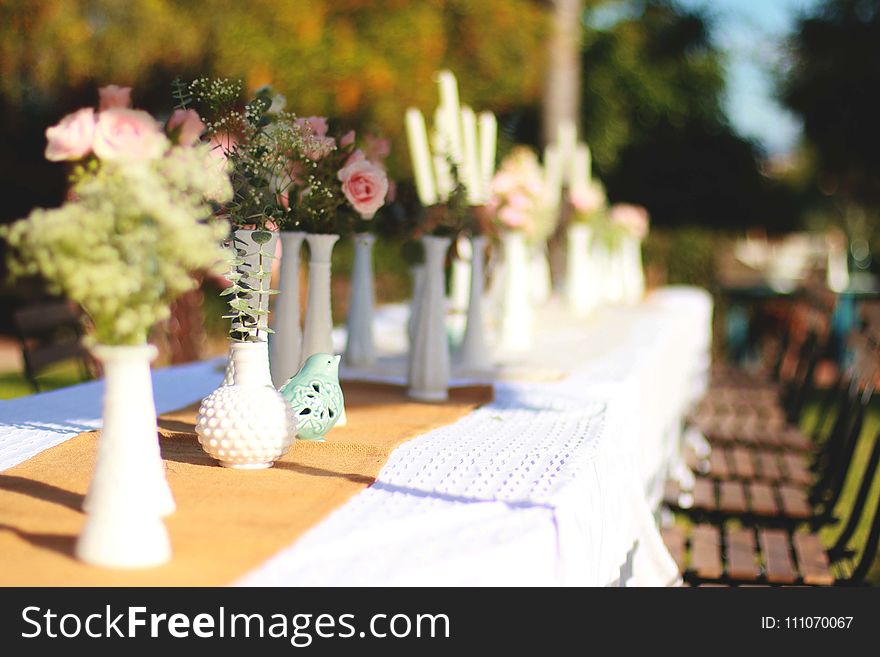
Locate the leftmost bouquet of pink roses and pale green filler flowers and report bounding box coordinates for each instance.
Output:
[3,86,232,345]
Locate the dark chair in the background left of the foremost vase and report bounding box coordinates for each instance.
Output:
[13,301,91,392]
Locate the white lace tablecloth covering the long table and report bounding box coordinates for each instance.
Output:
[0,288,712,585]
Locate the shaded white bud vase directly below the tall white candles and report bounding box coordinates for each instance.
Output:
[407,235,450,402]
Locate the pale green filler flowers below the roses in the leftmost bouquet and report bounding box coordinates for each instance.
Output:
[3,144,232,345]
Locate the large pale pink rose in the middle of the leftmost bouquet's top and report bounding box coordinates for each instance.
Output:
[94,108,168,162]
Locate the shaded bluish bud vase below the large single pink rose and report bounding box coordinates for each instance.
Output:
[344,233,376,367]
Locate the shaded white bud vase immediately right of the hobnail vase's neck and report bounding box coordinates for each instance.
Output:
[269,231,306,388]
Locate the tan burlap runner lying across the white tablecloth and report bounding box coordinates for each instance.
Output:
[0,383,492,586]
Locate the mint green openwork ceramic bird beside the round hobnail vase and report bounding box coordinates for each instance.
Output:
[280,353,345,441]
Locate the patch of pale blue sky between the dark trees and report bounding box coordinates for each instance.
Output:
[592,0,821,156]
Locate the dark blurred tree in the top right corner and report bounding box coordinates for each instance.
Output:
[781,0,880,210]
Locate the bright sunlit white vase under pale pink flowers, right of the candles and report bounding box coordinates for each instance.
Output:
[499,231,534,352]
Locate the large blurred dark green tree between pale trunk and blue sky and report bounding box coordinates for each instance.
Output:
[581,0,797,229]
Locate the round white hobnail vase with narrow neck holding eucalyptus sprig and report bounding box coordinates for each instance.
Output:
[196,342,296,470]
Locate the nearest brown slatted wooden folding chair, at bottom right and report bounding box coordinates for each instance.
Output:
[662,434,880,585]
